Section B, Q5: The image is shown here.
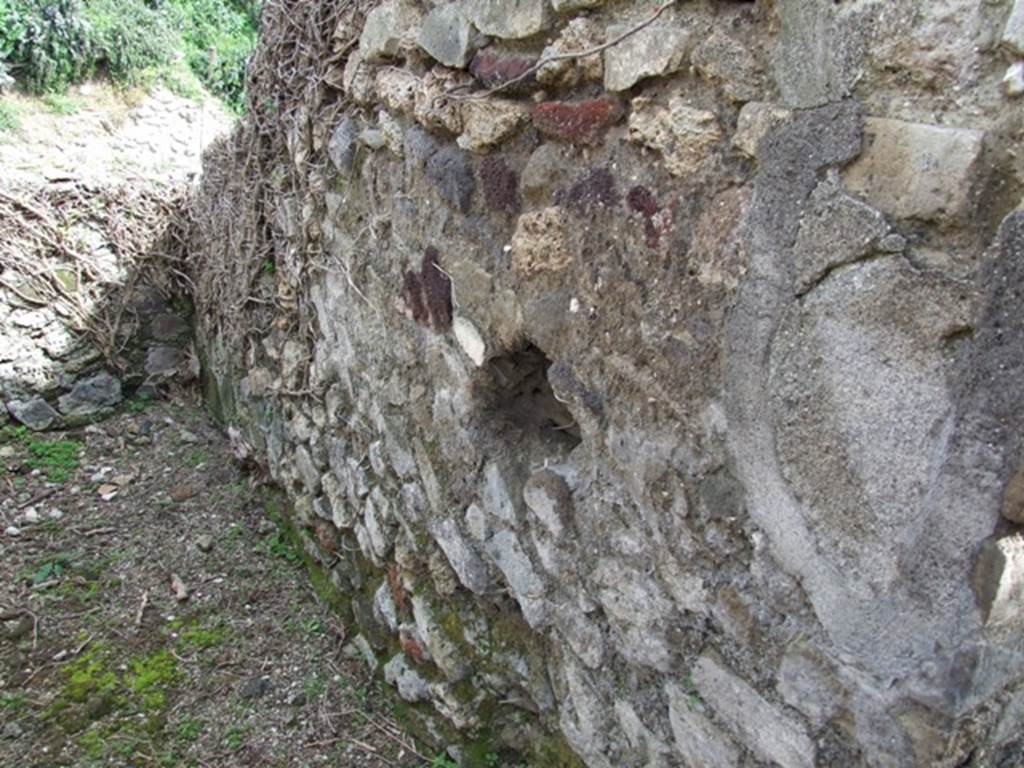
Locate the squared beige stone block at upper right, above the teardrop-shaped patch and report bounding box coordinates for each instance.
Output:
[844,118,984,221]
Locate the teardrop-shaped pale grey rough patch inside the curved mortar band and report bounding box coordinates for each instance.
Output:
[771,259,969,654]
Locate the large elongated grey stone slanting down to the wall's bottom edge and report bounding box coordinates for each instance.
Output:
[693,655,815,768]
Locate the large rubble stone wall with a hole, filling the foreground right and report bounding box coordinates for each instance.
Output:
[188,0,1024,768]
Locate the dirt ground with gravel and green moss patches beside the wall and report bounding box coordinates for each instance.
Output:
[0,394,434,768]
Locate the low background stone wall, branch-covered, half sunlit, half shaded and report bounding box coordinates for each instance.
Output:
[0,181,198,430]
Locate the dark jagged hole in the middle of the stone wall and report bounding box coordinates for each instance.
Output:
[473,343,581,454]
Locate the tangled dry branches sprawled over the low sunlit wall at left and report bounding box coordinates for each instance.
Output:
[0,181,187,369]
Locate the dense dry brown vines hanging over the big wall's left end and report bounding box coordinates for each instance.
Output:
[188,0,379,382]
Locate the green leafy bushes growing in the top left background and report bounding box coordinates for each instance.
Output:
[0,0,259,111]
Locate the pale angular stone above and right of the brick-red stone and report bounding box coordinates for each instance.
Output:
[604,23,693,91]
